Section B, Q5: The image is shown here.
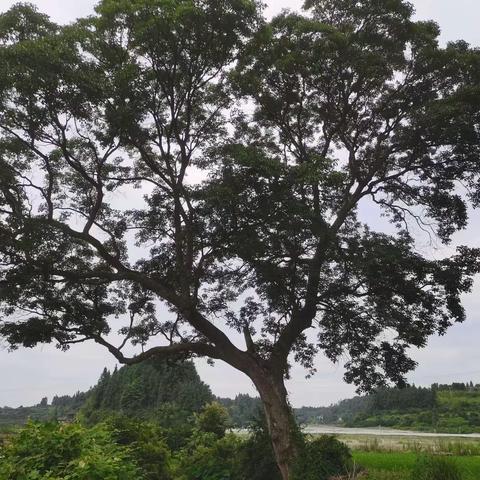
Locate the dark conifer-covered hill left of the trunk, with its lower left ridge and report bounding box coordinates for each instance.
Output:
[0,359,214,426]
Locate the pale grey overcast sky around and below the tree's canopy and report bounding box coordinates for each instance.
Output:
[0,0,480,406]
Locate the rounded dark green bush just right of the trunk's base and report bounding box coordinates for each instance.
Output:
[292,435,353,480]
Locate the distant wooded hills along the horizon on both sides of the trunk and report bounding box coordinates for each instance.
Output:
[0,368,480,433]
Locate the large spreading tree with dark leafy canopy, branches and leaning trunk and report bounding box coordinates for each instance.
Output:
[0,0,480,479]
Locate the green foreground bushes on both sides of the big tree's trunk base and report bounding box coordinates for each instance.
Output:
[0,403,353,480]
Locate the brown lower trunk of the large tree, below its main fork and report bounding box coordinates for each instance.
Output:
[252,372,297,480]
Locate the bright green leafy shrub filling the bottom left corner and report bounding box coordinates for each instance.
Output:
[0,422,144,480]
